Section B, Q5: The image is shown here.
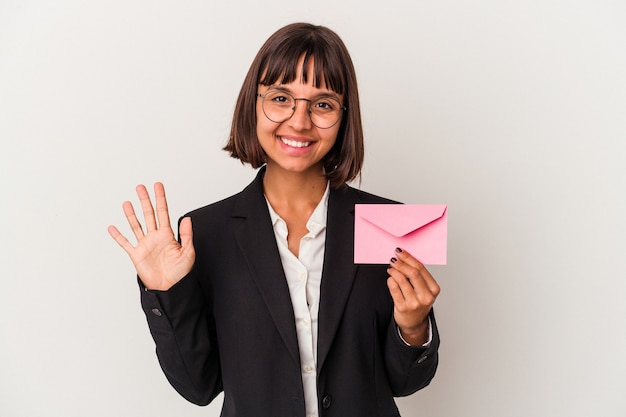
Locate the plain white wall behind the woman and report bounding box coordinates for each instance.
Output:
[0,0,626,417]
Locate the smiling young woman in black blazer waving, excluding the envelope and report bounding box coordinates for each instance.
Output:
[109,23,439,417]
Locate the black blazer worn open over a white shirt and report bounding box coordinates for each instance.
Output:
[141,169,439,417]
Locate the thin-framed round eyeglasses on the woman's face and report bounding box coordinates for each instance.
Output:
[257,90,347,129]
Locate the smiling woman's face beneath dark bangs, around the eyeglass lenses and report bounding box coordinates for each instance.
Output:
[256,59,343,175]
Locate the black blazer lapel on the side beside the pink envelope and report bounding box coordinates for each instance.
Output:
[317,186,358,373]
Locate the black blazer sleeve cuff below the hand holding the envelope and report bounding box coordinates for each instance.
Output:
[385,310,439,397]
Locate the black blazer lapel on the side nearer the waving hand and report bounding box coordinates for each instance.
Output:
[233,168,300,366]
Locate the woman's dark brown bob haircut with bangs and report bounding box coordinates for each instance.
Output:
[223,23,364,188]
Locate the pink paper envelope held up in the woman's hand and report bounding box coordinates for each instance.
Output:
[354,204,448,265]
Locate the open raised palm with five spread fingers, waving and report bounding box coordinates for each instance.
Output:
[108,182,196,291]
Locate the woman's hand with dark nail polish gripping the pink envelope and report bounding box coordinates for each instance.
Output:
[387,249,441,345]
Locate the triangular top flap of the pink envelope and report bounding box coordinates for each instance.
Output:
[355,204,447,237]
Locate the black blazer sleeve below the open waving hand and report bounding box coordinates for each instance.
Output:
[139,271,222,405]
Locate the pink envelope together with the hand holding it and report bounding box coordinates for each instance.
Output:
[354,204,448,346]
